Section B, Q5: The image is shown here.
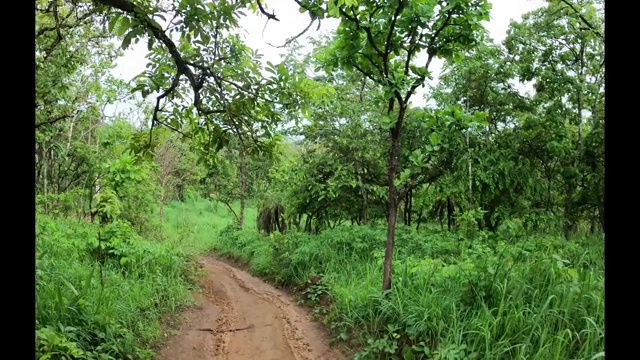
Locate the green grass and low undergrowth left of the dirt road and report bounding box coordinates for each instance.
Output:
[36,214,194,360]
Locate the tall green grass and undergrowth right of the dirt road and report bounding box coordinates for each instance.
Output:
[214,222,604,359]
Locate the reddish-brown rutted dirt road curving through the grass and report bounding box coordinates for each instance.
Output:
[159,257,346,360]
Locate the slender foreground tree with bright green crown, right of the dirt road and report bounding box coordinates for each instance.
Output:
[324,0,490,291]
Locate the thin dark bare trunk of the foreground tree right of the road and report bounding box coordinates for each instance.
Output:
[382,100,406,291]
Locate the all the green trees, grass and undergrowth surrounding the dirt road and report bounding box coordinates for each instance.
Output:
[35,0,605,359]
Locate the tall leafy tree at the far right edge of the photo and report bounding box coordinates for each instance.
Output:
[505,0,604,238]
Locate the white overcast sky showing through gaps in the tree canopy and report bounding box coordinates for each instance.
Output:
[108,0,545,120]
